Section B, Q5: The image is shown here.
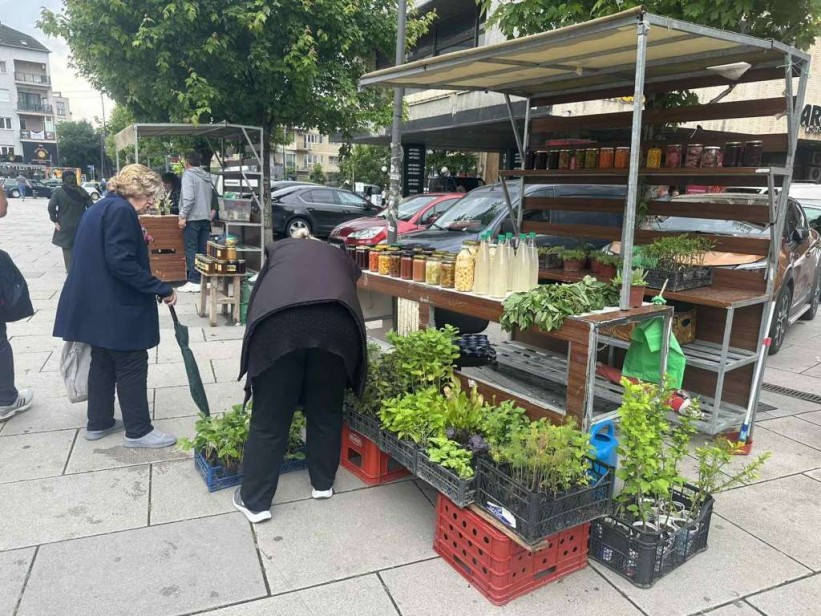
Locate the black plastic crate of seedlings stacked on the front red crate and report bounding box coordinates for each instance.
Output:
[476,458,615,545]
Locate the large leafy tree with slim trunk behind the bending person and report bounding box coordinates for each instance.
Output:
[40,0,430,239]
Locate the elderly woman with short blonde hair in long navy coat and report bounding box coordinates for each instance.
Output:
[54,165,177,448]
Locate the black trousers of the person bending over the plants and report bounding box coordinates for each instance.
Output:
[241,349,348,511]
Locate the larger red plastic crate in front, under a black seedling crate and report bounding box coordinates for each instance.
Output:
[433,495,590,605]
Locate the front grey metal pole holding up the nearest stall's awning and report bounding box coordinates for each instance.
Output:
[619,20,650,310]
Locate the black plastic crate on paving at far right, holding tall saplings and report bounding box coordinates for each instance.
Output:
[590,486,713,588]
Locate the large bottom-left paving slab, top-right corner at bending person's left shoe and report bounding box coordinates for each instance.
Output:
[18,513,266,616]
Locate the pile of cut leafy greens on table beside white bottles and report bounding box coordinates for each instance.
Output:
[500,276,618,332]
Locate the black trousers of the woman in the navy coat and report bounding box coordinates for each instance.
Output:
[88,346,154,438]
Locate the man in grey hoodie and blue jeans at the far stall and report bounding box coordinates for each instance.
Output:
[178,151,215,293]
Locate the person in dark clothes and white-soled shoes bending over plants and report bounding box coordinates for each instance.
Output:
[234,233,368,523]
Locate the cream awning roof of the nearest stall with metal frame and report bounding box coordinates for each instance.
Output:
[360,8,808,105]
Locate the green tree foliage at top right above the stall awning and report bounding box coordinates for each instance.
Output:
[478,0,821,49]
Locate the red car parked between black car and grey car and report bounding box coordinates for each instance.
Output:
[328,193,465,246]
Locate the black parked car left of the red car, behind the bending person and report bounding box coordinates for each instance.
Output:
[271,184,378,237]
